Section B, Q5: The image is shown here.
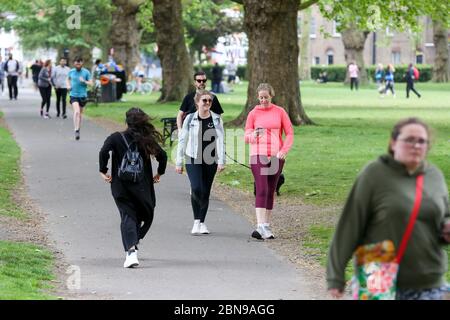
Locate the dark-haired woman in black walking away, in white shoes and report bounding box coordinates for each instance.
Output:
[99,108,167,268]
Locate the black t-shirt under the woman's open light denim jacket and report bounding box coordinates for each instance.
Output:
[197,116,217,164]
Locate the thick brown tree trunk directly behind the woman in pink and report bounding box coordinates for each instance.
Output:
[232,0,312,125]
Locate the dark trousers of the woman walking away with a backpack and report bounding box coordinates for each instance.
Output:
[114,197,154,251]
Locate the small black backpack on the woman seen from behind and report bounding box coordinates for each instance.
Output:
[118,132,144,183]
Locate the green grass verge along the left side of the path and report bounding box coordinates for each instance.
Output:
[0,113,54,300]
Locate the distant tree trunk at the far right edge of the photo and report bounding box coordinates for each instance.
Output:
[433,21,450,82]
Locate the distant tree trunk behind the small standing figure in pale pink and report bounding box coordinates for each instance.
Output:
[341,26,369,84]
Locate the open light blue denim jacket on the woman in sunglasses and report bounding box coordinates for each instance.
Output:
[176,111,225,167]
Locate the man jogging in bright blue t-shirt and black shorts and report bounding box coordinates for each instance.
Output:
[67,57,93,140]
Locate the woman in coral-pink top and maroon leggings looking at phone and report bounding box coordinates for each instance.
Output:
[245,83,294,239]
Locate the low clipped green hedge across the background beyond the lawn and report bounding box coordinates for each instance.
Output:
[194,64,433,82]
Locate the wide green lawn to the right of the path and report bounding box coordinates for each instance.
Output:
[87,82,450,280]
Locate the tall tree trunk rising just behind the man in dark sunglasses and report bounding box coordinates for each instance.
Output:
[153,0,193,102]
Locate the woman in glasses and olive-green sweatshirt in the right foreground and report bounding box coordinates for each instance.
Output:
[327,118,450,300]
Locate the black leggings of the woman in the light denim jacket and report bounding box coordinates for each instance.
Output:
[186,158,217,222]
